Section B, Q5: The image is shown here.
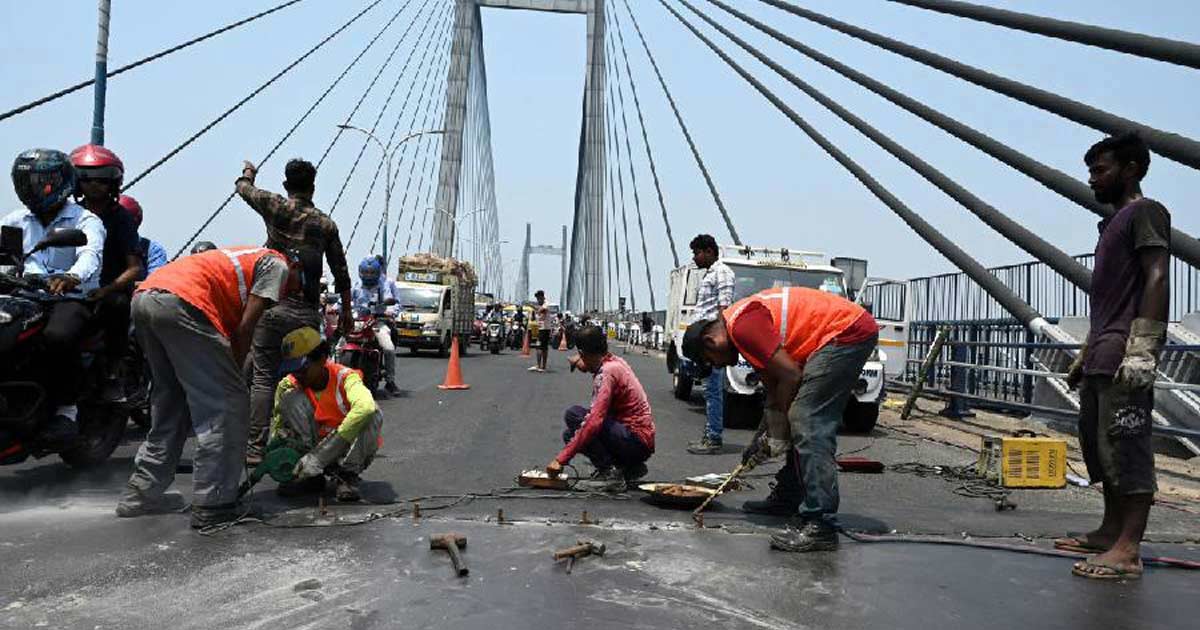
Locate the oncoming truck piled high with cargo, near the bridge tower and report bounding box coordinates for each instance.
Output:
[396,253,476,356]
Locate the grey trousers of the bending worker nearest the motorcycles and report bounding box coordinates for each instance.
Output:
[130,292,250,506]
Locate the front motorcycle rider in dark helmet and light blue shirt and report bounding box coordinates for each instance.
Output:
[0,149,104,446]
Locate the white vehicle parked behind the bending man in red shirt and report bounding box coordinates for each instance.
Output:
[666,245,887,433]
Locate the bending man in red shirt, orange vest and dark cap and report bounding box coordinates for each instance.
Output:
[683,287,880,552]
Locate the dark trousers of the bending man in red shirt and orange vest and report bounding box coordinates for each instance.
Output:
[775,337,877,521]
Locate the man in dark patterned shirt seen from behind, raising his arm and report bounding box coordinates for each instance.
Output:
[235,160,354,464]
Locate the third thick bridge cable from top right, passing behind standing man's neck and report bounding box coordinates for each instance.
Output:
[708,0,1200,266]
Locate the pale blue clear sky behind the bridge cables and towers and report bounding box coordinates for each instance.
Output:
[0,0,1200,308]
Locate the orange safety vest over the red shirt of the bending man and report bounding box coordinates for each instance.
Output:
[724,287,866,368]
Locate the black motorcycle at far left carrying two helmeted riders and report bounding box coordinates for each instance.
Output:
[0,227,132,468]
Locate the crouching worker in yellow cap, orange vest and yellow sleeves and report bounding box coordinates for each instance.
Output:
[268,328,383,502]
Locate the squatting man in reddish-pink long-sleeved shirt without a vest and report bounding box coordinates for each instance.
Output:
[546,326,654,492]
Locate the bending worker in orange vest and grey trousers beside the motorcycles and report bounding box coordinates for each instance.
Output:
[116,247,302,528]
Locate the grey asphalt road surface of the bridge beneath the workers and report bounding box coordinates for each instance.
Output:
[0,352,1200,630]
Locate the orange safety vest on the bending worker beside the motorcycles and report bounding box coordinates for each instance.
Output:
[138,247,286,337]
